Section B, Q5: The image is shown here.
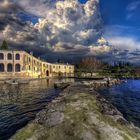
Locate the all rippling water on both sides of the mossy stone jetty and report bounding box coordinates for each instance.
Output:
[0,79,140,140]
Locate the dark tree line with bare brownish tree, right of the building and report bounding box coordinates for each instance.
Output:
[76,57,140,78]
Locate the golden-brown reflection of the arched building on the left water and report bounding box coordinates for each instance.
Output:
[0,79,52,106]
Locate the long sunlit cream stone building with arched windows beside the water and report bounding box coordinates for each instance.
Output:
[0,50,74,78]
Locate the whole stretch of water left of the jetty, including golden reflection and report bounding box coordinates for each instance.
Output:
[0,79,74,140]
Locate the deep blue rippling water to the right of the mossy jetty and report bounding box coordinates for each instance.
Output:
[99,80,140,127]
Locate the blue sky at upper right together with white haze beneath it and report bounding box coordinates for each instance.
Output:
[100,0,140,49]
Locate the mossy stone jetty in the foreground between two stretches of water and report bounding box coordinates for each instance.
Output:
[11,84,140,140]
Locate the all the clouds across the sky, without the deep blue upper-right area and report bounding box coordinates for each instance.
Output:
[0,0,140,62]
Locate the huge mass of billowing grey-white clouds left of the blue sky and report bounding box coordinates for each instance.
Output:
[0,0,109,62]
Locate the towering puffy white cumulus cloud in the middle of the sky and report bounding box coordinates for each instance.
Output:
[17,0,105,48]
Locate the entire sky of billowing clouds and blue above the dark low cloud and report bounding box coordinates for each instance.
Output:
[0,0,140,62]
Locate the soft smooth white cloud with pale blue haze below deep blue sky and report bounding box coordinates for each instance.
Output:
[104,25,140,50]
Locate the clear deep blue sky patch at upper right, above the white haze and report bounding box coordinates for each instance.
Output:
[100,0,140,40]
